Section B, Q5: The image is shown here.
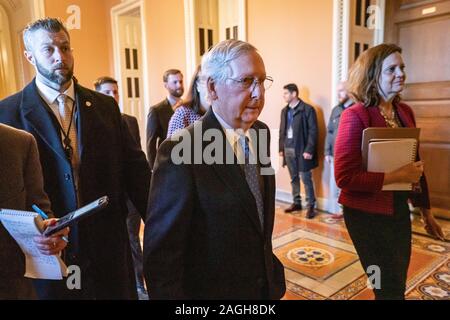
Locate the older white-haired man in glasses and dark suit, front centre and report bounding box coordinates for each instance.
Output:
[144,40,285,300]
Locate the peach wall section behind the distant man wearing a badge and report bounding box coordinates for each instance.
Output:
[247,0,333,202]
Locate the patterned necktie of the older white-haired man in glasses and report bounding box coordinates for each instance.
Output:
[244,137,264,230]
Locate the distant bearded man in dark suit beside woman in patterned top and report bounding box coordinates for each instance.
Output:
[147,69,184,169]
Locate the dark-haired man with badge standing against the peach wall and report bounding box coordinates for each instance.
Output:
[279,83,319,219]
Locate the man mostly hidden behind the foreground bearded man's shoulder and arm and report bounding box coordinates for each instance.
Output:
[94,77,148,300]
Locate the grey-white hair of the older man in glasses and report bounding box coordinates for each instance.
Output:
[201,39,258,82]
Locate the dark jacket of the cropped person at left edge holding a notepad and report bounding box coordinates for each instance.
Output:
[0,124,53,299]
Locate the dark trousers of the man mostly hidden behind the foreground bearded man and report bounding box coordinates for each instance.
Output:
[127,200,144,288]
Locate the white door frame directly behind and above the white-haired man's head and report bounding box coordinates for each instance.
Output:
[184,0,247,79]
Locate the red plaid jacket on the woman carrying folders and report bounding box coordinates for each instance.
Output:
[334,103,430,215]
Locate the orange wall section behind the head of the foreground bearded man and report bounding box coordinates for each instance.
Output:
[45,0,111,88]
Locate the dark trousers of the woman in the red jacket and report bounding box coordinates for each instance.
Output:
[344,192,411,300]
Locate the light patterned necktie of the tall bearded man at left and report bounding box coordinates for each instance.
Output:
[56,94,78,167]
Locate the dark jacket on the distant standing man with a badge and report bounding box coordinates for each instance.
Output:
[279,100,319,172]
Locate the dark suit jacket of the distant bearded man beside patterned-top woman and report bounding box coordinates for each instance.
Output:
[147,99,174,168]
